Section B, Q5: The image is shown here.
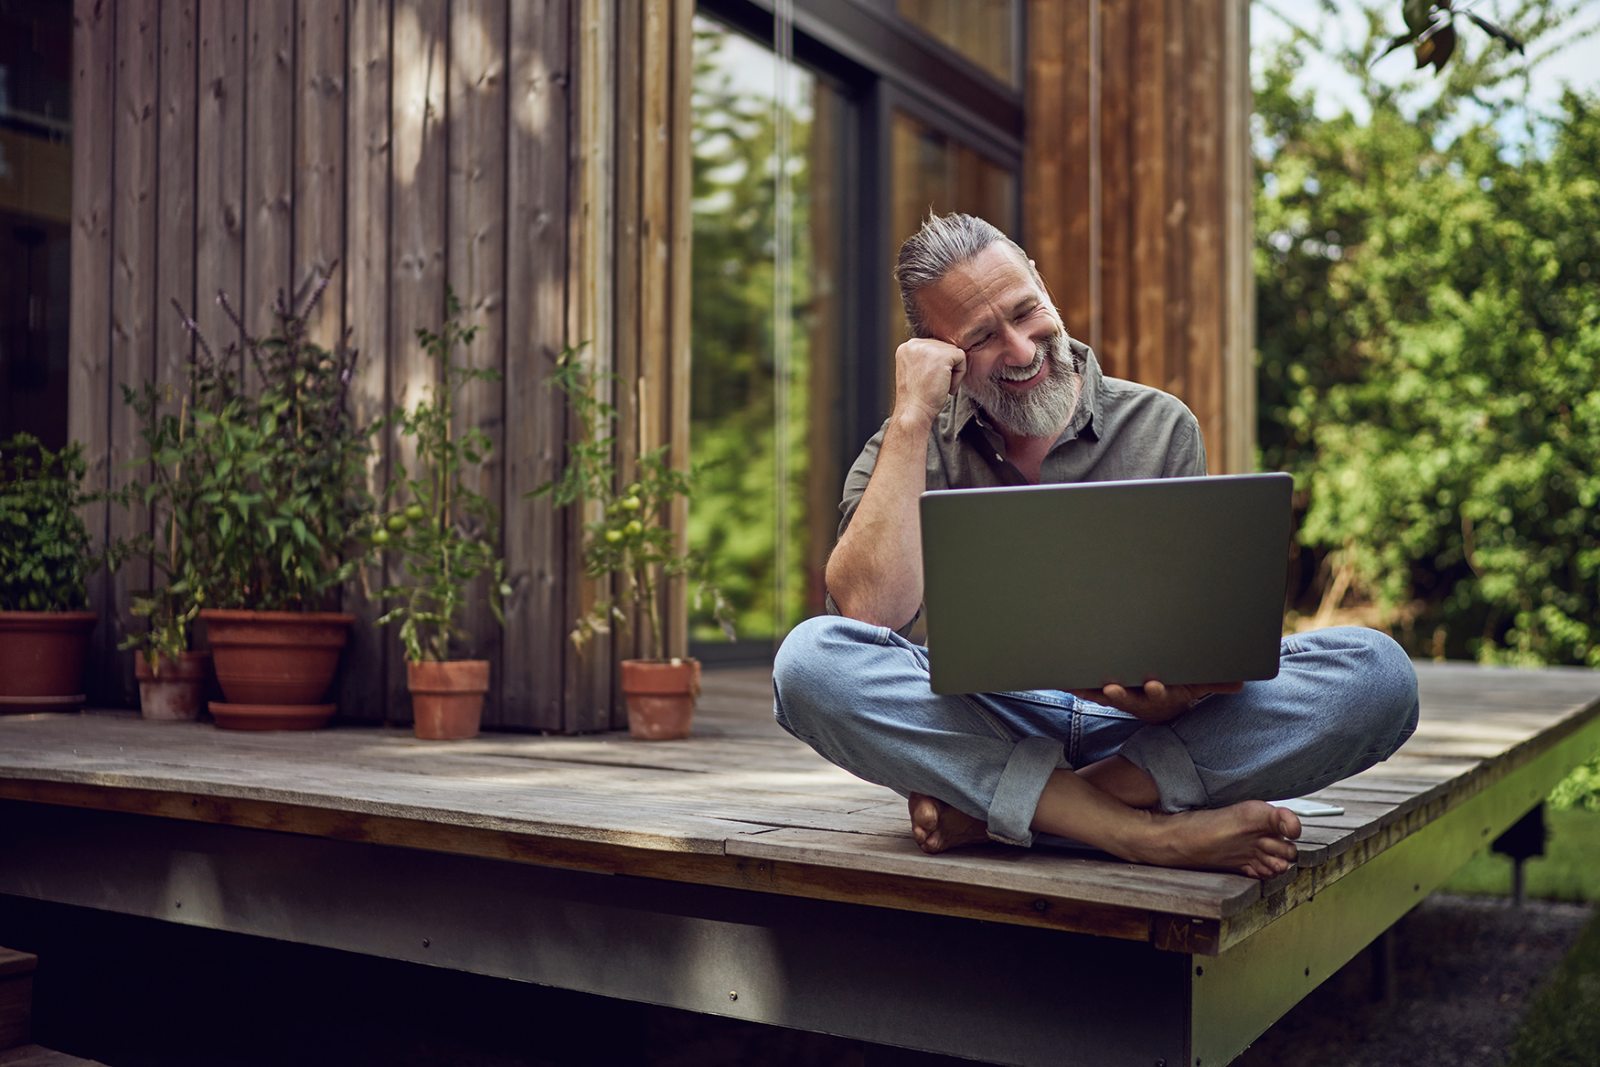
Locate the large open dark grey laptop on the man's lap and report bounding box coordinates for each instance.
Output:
[922,474,1293,694]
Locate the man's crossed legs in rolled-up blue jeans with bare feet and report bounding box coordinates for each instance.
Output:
[773,616,1416,877]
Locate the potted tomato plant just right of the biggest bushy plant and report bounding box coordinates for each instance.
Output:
[370,288,509,741]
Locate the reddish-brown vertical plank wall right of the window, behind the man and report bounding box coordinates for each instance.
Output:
[1022,0,1256,472]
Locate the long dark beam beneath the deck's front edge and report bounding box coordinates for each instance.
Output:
[0,801,1189,1067]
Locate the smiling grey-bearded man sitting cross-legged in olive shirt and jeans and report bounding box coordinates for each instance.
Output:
[773,214,1418,878]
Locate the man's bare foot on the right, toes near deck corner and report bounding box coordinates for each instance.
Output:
[1109,800,1301,881]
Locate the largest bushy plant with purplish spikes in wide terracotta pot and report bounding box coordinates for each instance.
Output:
[163,274,373,729]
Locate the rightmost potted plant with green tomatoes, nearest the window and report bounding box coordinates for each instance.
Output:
[530,349,733,741]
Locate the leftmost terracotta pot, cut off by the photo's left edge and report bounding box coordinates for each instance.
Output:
[0,611,99,715]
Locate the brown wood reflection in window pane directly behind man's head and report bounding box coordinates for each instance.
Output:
[885,110,1016,352]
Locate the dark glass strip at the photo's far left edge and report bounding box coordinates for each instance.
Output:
[0,3,72,448]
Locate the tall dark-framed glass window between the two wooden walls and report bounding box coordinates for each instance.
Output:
[690,0,1021,662]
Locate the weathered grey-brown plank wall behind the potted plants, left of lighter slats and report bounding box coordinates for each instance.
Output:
[70,0,582,729]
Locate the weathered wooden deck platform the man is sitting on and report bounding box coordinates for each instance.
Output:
[0,664,1600,1064]
